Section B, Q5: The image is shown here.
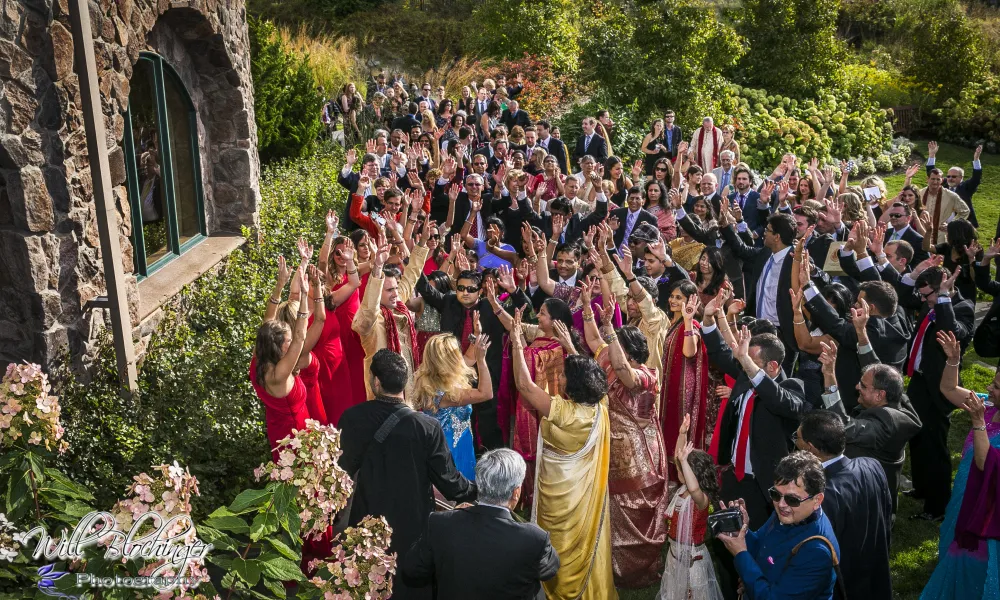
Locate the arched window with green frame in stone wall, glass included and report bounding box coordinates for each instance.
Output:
[122,52,206,279]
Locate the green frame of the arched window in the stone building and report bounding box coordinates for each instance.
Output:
[122,52,207,280]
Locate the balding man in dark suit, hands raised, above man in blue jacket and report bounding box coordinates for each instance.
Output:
[820,342,920,515]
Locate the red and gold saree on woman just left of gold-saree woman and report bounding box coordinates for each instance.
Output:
[497,337,564,506]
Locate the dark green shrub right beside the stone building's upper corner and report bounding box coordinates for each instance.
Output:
[248,19,323,162]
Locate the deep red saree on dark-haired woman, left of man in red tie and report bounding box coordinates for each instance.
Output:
[659,319,709,488]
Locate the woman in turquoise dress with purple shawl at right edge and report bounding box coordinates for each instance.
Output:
[920,332,1000,600]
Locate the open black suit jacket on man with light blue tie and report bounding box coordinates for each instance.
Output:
[722,227,830,354]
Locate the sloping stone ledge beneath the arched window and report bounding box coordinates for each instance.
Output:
[139,233,246,321]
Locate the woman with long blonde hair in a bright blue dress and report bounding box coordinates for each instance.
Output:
[413,330,493,481]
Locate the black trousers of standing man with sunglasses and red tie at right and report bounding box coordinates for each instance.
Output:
[906,373,952,516]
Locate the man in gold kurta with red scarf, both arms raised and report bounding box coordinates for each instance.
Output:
[351,237,428,400]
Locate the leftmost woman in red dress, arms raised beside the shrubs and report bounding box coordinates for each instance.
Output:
[250,259,322,462]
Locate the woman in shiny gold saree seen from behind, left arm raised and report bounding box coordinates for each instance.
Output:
[510,311,618,600]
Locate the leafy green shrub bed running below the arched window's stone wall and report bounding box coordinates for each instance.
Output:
[57,151,345,516]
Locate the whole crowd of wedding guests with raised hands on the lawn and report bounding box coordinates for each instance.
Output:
[250,75,1000,600]
